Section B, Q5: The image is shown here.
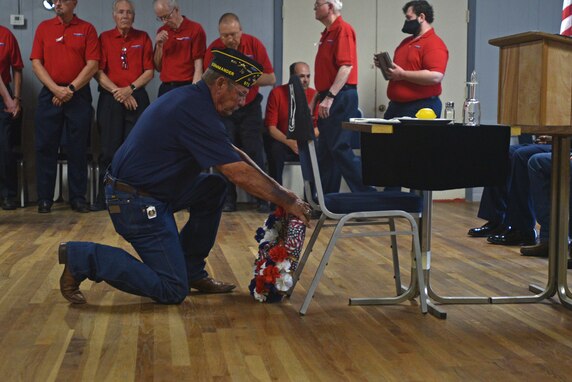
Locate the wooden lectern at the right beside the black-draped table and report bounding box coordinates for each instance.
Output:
[489,32,572,135]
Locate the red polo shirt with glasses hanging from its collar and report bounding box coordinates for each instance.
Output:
[99,28,153,87]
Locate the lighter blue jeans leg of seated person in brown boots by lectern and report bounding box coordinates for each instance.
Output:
[528,153,572,241]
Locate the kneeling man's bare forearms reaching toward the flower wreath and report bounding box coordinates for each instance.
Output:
[216,147,310,227]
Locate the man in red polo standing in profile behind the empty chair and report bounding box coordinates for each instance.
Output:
[314,0,375,193]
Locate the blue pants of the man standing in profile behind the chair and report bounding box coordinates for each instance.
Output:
[316,89,375,194]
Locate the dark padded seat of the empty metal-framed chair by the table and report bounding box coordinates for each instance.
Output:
[324,191,423,214]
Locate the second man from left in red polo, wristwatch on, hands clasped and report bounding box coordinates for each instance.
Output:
[30,0,101,213]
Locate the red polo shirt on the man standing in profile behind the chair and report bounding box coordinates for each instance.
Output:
[314,16,358,92]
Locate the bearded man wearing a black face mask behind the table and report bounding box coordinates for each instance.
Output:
[374,1,449,119]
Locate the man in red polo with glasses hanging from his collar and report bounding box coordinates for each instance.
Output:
[91,0,153,211]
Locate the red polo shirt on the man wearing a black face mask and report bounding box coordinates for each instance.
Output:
[387,29,449,102]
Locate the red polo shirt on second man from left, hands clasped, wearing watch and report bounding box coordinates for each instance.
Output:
[30,15,101,85]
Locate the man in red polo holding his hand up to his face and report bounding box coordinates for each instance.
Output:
[153,0,207,97]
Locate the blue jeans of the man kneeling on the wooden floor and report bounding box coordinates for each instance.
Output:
[68,174,226,304]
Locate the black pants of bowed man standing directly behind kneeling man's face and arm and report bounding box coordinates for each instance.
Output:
[224,94,264,203]
